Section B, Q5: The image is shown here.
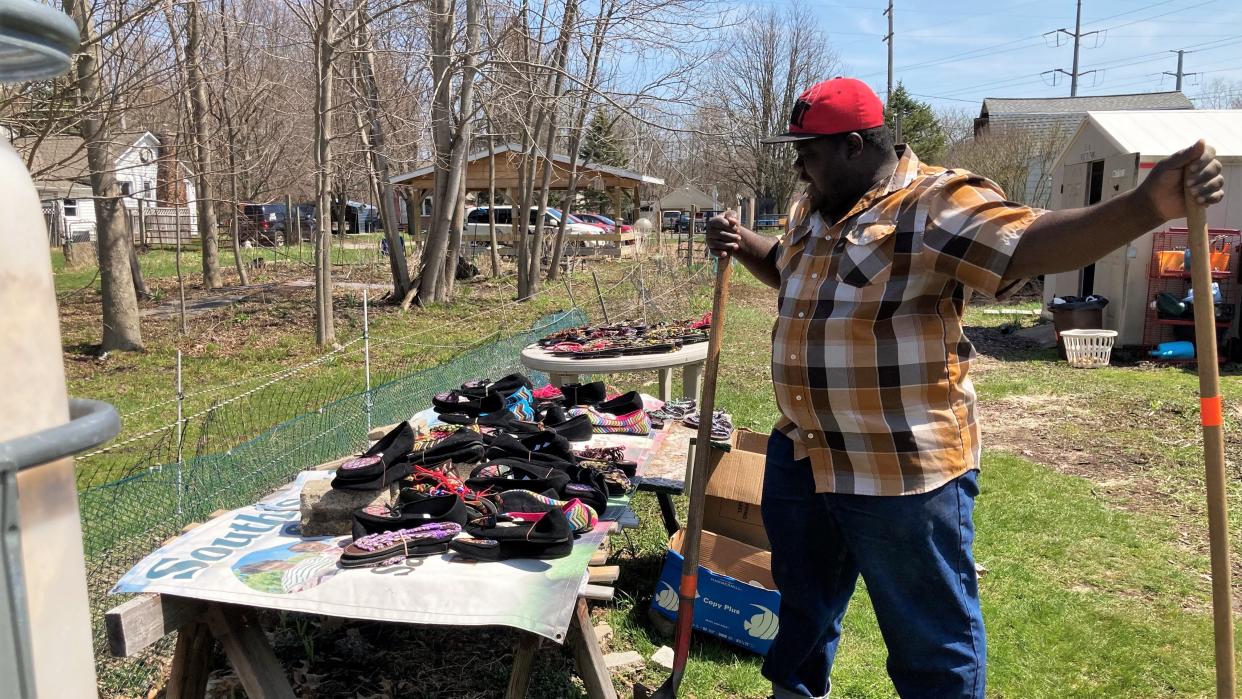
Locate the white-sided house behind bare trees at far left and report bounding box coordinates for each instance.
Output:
[12,132,197,240]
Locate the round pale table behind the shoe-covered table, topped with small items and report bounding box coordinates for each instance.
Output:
[522,343,707,401]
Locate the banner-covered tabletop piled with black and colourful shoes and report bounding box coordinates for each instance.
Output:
[113,374,732,642]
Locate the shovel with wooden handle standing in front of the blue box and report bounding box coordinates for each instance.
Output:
[633,258,733,699]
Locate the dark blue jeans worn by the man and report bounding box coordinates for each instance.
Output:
[763,432,986,699]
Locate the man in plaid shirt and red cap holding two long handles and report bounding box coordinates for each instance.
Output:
[708,78,1223,699]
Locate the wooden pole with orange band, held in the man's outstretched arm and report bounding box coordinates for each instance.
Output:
[1186,190,1237,699]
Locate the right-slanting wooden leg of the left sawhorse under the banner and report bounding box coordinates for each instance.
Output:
[206,603,297,699]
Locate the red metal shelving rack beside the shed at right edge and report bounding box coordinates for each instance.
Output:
[1143,228,1242,360]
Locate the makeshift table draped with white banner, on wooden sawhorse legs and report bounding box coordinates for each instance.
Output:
[106,416,667,699]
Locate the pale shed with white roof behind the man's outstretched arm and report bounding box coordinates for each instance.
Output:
[1043,109,1242,345]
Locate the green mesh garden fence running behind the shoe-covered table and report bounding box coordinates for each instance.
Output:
[87,308,587,695]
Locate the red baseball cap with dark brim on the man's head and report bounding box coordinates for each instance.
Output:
[760,78,884,144]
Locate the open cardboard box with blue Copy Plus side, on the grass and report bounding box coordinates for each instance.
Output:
[651,431,780,656]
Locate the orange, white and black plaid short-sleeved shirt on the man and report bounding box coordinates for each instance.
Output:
[771,148,1043,495]
